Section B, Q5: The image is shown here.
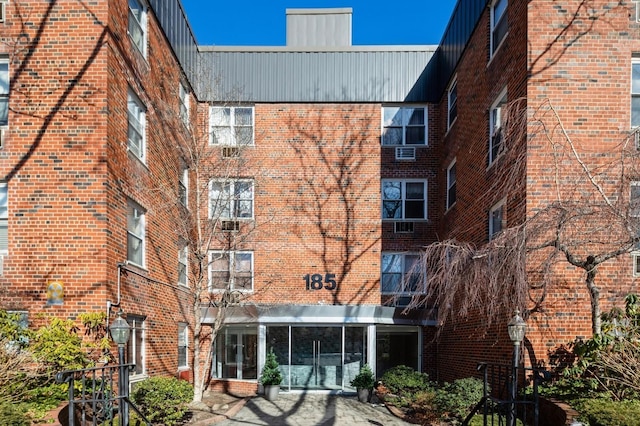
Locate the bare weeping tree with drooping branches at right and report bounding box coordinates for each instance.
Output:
[400,100,640,340]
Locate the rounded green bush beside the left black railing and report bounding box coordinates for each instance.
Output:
[131,377,193,426]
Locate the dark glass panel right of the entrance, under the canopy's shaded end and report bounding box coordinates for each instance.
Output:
[376,327,420,377]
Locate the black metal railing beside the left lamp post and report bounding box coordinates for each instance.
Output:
[56,364,151,426]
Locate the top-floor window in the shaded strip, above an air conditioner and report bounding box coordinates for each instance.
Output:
[382,107,427,145]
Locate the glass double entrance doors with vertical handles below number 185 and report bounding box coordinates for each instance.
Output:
[290,326,343,389]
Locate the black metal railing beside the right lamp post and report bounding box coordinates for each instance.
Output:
[462,363,544,426]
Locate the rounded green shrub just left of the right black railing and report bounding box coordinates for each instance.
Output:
[435,377,484,420]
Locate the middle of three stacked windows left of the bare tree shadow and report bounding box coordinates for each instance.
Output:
[209,180,253,219]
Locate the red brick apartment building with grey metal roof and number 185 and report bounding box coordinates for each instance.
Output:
[0,0,640,390]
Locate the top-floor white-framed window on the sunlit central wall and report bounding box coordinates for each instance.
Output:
[210,107,253,146]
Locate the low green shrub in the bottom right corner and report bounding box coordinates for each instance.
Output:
[576,399,640,426]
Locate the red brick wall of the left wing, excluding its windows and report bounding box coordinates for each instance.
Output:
[0,1,192,380]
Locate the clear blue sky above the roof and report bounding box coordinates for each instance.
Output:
[182,0,456,46]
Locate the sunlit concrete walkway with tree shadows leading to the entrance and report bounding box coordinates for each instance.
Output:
[215,391,409,426]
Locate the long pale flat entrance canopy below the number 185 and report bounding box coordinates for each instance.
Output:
[202,305,436,326]
